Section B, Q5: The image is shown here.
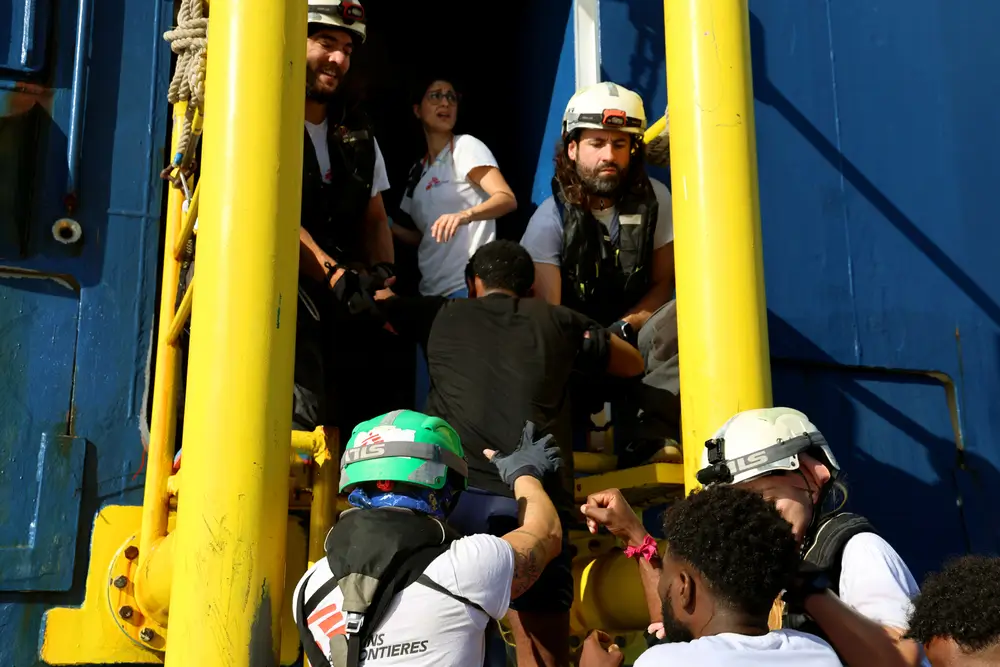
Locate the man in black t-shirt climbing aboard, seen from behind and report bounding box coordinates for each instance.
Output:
[366,241,643,667]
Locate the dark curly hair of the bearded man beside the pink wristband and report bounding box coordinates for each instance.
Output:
[663,486,799,618]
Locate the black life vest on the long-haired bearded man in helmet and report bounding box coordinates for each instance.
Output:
[552,178,659,326]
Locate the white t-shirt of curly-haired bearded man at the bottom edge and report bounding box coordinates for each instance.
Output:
[634,630,841,667]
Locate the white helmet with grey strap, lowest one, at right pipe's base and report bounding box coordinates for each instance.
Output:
[698,408,840,486]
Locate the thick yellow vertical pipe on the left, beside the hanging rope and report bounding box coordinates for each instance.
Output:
[166,0,306,667]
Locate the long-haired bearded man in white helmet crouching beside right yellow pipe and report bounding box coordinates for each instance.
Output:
[521,82,680,467]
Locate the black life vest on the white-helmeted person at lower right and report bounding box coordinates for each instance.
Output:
[781,512,877,643]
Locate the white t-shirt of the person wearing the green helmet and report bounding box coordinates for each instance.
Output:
[292,535,514,667]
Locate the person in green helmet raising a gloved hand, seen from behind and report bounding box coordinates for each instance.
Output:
[292,410,562,667]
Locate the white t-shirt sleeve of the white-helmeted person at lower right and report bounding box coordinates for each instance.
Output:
[840,533,930,667]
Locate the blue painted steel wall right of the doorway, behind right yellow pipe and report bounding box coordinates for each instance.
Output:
[588,0,1000,576]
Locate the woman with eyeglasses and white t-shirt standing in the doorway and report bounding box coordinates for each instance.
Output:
[392,73,517,409]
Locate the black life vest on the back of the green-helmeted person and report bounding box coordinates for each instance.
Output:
[295,508,486,667]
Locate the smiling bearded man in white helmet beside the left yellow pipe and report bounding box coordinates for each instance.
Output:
[293,0,393,438]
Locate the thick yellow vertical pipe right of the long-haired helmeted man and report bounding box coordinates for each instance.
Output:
[664,0,771,491]
